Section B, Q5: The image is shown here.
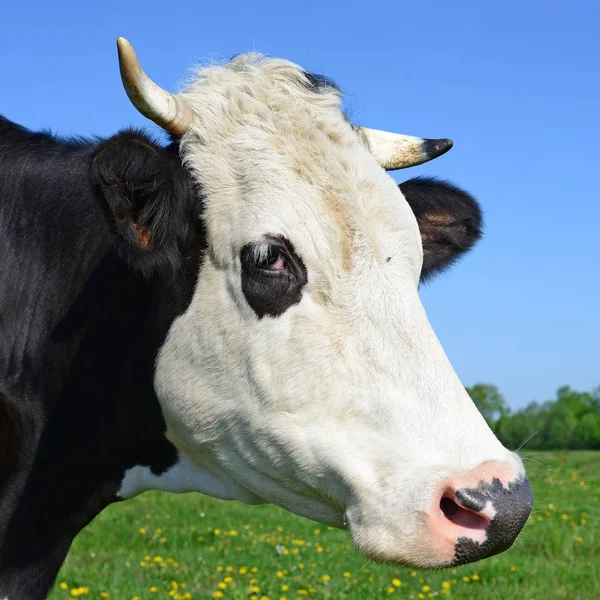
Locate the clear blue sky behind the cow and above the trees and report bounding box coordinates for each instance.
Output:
[0,0,600,407]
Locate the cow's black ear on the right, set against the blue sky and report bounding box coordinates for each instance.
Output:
[399,177,483,281]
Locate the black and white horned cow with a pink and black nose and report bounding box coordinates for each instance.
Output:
[0,38,532,600]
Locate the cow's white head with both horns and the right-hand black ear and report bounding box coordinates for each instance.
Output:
[101,40,532,567]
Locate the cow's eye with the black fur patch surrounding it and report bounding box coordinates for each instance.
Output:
[240,236,307,317]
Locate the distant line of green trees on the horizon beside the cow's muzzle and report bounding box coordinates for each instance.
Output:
[466,383,600,450]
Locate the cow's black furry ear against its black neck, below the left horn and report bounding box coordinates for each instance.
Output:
[92,130,193,276]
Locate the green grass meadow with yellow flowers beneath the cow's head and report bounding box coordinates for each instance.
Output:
[50,452,600,600]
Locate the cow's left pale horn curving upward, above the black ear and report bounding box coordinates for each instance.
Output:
[117,37,194,135]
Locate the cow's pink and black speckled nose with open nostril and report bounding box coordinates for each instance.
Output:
[428,461,533,565]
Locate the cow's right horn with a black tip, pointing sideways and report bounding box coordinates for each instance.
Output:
[358,127,453,171]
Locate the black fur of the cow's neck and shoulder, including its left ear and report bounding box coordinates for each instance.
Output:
[0,118,204,600]
